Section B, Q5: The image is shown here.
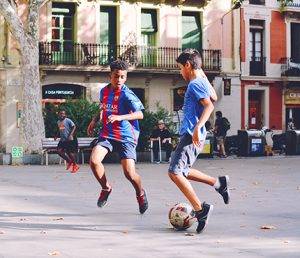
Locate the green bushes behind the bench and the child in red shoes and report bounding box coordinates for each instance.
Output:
[43,99,99,137]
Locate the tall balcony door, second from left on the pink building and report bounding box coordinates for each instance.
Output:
[99,6,117,65]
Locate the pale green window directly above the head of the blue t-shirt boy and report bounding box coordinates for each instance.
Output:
[182,12,202,50]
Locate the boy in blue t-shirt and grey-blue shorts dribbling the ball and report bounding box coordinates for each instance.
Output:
[168,49,230,233]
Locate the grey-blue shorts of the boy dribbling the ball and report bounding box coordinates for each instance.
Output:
[168,134,205,177]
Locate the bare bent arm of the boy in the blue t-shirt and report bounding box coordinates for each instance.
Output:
[193,98,214,147]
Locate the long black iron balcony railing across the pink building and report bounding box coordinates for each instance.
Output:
[39,42,221,72]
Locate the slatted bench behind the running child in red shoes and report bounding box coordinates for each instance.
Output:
[41,137,95,166]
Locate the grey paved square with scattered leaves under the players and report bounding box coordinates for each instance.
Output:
[0,156,300,258]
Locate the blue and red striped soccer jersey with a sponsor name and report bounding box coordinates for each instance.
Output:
[99,84,144,144]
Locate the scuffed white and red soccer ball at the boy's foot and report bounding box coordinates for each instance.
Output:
[169,203,197,230]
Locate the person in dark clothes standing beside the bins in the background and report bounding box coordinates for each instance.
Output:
[214,111,230,158]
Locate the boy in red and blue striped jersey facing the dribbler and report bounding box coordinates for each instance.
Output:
[87,60,148,214]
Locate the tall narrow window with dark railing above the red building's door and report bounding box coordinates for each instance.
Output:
[249,20,265,75]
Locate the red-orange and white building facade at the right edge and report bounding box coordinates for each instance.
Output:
[240,0,300,131]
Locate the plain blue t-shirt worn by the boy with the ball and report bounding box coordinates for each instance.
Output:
[180,78,210,139]
